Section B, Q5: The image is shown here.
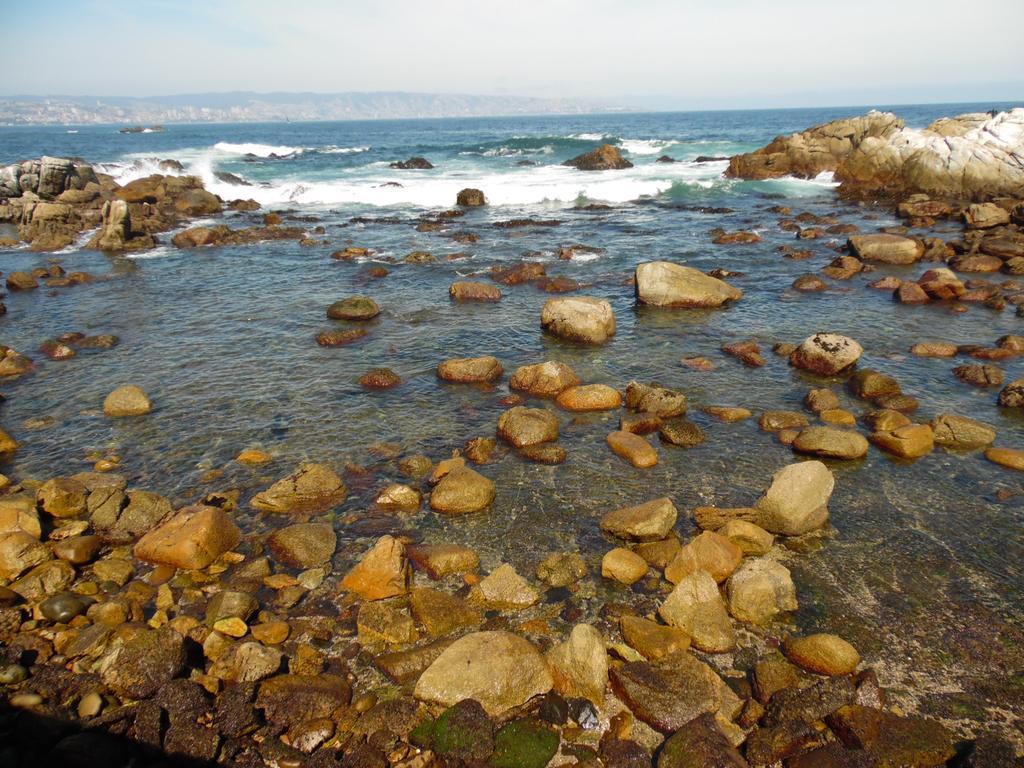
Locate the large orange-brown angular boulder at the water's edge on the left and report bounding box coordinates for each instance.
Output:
[132,505,242,570]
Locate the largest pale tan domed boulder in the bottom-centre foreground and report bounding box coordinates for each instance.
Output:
[414,632,554,716]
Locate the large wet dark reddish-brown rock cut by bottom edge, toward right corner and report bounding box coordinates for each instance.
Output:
[828,705,956,767]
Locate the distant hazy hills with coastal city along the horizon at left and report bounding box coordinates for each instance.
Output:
[0,91,628,125]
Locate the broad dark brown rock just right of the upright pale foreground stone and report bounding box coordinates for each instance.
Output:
[611,652,725,733]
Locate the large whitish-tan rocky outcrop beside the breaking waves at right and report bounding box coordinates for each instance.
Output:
[726,109,1024,201]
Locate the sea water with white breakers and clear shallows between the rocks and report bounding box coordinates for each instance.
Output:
[0,104,1024,738]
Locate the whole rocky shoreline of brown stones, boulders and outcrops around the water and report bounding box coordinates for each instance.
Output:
[0,110,1024,768]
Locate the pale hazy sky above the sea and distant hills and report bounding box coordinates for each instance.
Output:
[8,0,1024,109]
